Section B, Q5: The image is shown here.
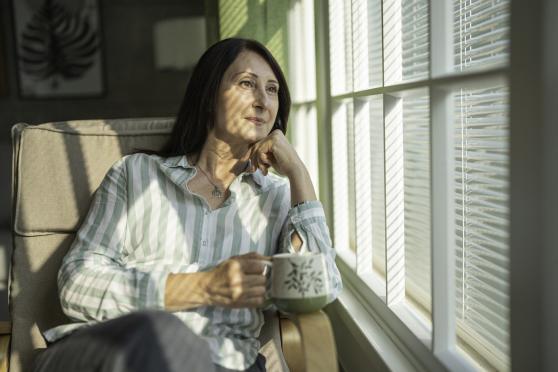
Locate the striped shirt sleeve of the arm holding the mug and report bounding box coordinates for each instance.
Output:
[58,158,168,322]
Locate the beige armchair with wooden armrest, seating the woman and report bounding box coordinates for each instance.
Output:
[0,119,337,372]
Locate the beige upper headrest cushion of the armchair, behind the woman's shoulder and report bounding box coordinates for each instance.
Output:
[14,119,173,236]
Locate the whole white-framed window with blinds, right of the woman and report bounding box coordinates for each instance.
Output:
[320,0,510,371]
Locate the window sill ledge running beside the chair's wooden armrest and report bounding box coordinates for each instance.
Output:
[326,252,447,372]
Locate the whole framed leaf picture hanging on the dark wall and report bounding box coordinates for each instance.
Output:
[12,0,104,98]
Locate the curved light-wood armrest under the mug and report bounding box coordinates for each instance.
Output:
[280,311,338,372]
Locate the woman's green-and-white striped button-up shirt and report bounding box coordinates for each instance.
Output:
[45,154,341,369]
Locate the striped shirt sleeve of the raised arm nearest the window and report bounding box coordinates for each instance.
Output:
[279,200,343,303]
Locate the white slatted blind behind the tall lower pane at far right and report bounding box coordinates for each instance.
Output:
[455,88,509,370]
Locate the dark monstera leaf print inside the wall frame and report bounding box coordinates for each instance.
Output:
[16,0,101,95]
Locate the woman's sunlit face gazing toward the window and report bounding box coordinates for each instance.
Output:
[214,51,279,145]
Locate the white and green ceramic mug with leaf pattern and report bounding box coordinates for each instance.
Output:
[266,253,329,313]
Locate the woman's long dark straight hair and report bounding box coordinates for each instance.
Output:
[157,38,291,156]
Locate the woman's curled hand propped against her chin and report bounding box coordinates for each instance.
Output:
[247,129,306,178]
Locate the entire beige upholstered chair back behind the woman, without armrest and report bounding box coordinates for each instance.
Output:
[9,118,174,372]
